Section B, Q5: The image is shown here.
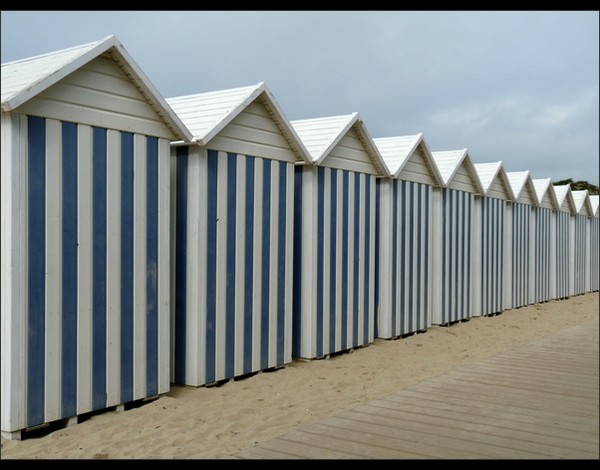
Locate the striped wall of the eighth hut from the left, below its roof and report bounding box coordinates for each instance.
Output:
[529,207,556,303]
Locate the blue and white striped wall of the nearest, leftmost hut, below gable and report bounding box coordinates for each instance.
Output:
[1,113,170,432]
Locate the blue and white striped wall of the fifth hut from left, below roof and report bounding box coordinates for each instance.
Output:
[431,188,475,325]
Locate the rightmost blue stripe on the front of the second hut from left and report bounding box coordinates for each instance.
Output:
[277,162,288,365]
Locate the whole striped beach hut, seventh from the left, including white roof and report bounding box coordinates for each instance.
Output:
[504,170,538,309]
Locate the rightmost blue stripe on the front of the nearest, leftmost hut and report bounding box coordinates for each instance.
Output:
[146,137,157,397]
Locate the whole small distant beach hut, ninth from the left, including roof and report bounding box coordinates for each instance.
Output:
[554,184,575,299]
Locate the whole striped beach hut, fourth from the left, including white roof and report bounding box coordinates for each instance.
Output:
[373,134,442,339]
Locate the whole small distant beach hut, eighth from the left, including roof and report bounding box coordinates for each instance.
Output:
[529,178,558,303]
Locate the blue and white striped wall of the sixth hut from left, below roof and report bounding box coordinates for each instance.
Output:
[473,196,506,316]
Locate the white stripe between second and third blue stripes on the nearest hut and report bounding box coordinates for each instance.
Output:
[77,125,92,414]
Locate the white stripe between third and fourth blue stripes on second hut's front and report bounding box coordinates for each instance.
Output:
[252,158,263,371]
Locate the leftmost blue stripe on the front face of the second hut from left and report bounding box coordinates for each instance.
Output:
[205,150,219,384]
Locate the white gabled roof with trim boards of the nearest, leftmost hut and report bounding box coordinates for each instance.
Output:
[2,35,191,140]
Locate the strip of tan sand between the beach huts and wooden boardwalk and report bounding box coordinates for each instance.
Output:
[1,292,598,459]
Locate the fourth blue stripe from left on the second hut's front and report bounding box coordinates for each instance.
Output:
[260,159,271,369]
